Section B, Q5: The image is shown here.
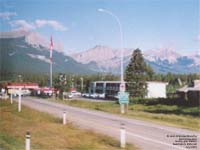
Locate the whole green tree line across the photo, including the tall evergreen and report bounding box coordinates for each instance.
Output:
[0,49,200,97]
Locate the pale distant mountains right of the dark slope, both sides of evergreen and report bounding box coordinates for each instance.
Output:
[70,45,200,73]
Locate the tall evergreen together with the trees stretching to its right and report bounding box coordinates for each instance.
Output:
[125,49,200,98]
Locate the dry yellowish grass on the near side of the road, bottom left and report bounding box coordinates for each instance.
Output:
[0,100,135,150]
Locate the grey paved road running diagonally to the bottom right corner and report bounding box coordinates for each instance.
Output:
[16,97,200,150]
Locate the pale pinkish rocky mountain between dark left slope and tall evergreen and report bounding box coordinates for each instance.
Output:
[70,45,132,72]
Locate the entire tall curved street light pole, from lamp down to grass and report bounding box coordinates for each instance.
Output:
[98,8,128,114]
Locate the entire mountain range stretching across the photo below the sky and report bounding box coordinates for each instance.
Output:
[0,30,200,74]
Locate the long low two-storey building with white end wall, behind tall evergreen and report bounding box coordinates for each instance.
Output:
[89,81,167,98]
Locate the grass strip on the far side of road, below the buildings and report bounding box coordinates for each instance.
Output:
[48,100,200,130]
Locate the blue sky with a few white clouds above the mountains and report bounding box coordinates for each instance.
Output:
[0,0,200,53]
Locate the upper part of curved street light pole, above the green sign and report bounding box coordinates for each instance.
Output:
[98,8,125,84]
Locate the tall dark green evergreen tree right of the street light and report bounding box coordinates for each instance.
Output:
[125,49,153,97]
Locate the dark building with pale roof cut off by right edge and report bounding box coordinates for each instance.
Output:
[176,80,200,103]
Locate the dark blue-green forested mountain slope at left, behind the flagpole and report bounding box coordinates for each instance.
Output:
[0,33,94,74]
